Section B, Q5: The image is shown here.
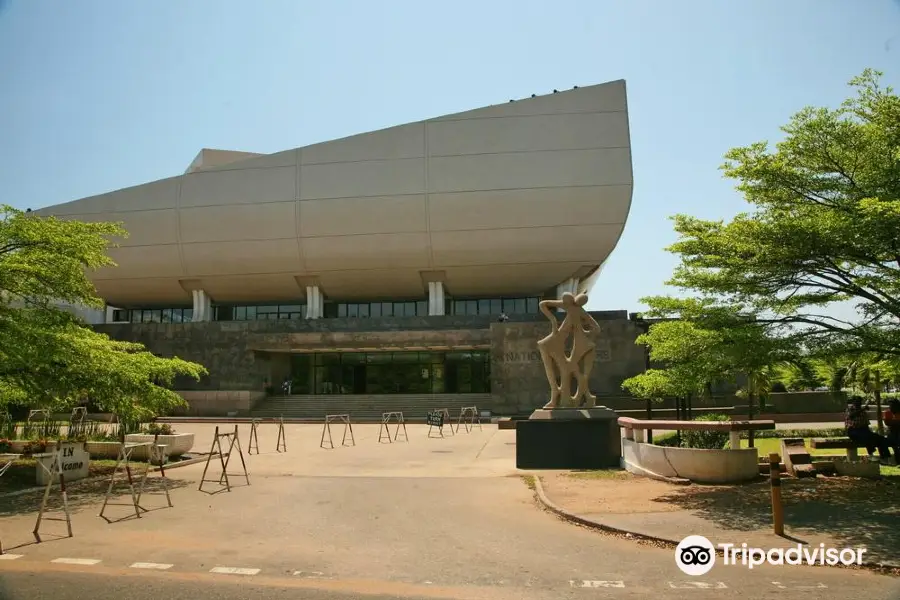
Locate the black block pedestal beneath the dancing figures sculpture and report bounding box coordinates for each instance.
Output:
[516,406,622,469]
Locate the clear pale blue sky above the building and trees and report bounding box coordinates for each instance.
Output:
[0,0,900,310]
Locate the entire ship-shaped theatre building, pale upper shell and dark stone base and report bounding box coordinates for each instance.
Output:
[36,81,644,413]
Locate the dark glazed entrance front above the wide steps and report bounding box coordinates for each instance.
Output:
[291,350,491,395]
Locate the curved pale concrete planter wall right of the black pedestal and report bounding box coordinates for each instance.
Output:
[622,438,759,483]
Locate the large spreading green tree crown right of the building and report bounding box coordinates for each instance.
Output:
[645,70,900,356]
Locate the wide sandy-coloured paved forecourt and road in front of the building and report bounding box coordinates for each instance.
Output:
[0,424,900,600]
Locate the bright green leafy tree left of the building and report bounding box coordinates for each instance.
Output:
[0,206,206,420]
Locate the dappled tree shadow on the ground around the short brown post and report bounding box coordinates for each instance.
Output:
[654,476,900,562]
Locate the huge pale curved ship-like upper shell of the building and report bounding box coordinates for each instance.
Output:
[36,81,632,306]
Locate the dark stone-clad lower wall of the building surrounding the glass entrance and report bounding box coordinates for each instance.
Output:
[95,311,644,415]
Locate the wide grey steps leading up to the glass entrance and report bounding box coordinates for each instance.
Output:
[250,394,493,422]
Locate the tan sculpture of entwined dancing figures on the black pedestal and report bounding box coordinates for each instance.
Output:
[538,292,600,409]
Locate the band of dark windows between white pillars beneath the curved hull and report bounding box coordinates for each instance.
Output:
[113,297,539,323]
